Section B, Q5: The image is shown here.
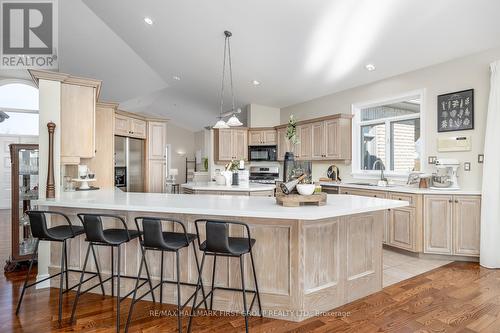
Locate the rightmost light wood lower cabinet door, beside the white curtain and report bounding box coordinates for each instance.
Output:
[453,196,481,256]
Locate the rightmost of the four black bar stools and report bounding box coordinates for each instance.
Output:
[188,219,262,332]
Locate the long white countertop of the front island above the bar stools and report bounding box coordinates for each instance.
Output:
[35,190,408,220]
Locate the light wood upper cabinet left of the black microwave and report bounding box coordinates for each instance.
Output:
[214,128,248,162]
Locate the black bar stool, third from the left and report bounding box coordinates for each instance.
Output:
[125,217,207,332]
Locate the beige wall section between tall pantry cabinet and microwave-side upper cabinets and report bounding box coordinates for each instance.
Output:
[167,123,195,184]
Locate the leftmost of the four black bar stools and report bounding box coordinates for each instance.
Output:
[16,210,104,326]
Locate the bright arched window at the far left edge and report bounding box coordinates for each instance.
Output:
[0,82,38,136]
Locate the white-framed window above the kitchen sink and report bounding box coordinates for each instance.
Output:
[353,94,422,176]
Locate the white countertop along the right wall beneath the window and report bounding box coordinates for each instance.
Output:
[320,182,481,195]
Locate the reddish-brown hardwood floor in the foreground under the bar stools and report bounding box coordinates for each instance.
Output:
[0,262,500,333]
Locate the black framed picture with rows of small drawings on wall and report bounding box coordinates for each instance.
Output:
[437,89,474,132]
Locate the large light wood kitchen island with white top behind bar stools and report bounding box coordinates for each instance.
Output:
[37,190,408,321]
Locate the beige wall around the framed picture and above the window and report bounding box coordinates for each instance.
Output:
[281,48,500,189]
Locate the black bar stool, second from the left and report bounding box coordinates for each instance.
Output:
[71,213,155,332]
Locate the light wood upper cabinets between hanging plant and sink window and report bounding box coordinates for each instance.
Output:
[277,114,352,161]
